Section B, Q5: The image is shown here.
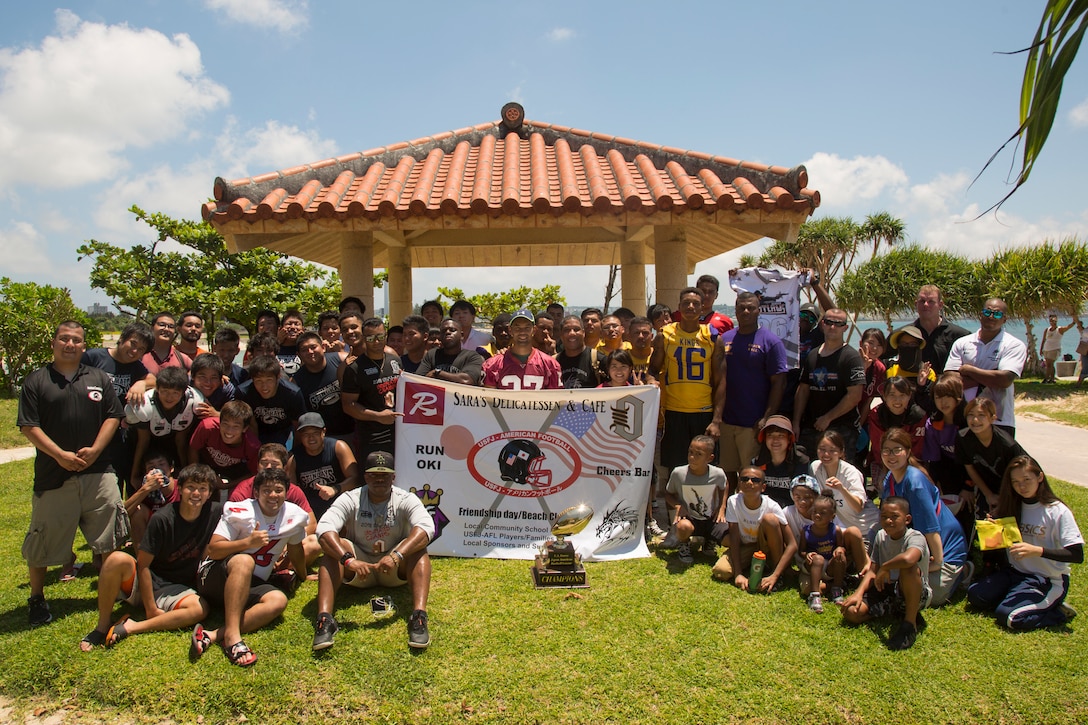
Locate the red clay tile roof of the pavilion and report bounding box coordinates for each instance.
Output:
[202,109,819,224]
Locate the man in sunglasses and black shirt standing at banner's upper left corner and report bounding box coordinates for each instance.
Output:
[341,316,400,460]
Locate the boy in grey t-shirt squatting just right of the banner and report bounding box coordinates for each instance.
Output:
[661,431,727,564]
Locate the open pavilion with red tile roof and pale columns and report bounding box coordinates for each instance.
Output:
[201,103,819,320]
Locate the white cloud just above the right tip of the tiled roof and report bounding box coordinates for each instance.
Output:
[805,151,907,209]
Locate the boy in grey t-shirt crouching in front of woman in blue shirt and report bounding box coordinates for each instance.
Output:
[839,496,930,650]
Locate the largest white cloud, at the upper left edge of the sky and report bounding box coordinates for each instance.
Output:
[0,10,230,189]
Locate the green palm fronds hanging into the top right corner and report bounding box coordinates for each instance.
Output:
[975,0,1088,216]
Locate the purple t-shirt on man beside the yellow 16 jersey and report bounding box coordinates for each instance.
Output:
[721,328,789,428]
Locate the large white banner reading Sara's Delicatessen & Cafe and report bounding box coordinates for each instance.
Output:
[396,373,658,561]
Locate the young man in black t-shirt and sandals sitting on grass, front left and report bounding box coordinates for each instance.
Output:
[79,464,222,652]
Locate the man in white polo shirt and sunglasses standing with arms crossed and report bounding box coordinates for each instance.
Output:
[944,297,1027,435]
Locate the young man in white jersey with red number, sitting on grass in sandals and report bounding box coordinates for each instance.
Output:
[189,468,310,667]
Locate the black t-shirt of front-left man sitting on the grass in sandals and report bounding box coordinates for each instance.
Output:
[139,501,223,588]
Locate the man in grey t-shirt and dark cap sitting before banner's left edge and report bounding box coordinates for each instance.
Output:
[313,451,434,650]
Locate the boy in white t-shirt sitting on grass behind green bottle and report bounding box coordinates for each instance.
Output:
[712,466,798,592]
